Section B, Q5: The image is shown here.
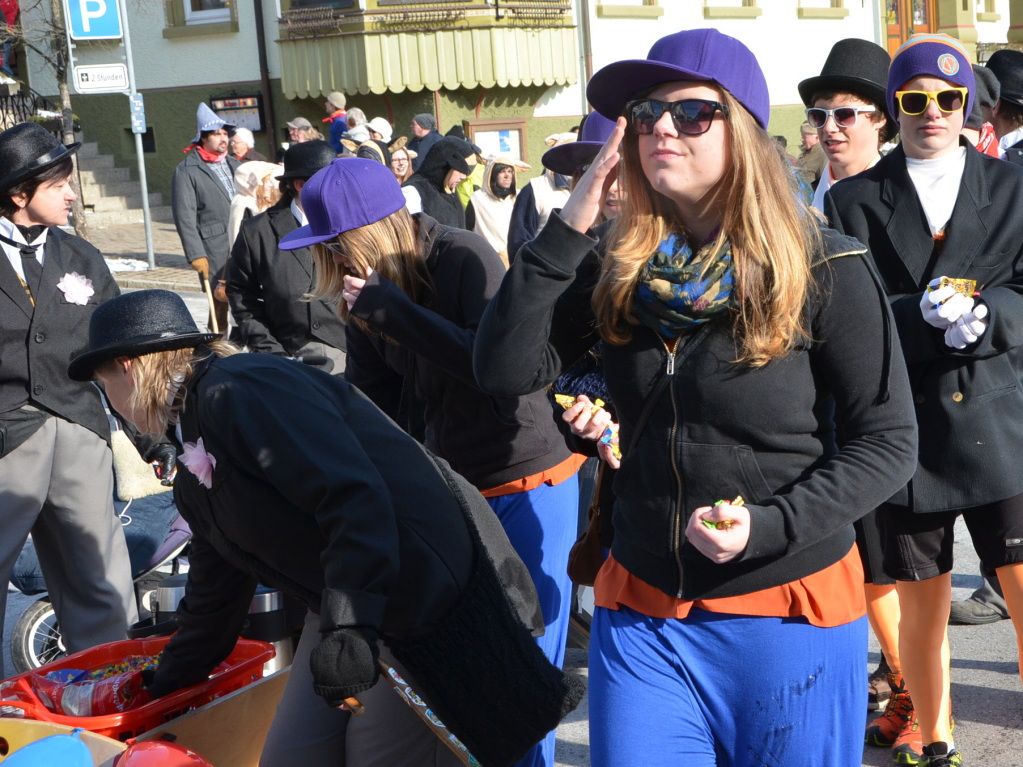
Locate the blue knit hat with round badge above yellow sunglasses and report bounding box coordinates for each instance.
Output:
[888,35,976,121]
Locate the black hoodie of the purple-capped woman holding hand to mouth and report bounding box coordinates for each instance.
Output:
[345,214,571,490]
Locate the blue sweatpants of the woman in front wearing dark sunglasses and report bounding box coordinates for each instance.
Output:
[589,607,866,767]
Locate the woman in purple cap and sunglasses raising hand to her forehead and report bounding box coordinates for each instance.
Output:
[474,30,916,767]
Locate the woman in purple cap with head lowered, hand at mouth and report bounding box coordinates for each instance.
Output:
[280,156,593,767]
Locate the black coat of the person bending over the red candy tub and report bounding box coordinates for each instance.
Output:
[155,354,542,691]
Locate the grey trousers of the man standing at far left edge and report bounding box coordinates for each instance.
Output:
[0,417,138,677]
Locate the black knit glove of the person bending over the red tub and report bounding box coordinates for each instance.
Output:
[309,627,380,708]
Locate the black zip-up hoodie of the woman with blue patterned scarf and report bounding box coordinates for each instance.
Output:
[475,214,917,599]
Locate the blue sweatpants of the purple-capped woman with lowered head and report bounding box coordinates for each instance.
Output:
[487,475,579,767]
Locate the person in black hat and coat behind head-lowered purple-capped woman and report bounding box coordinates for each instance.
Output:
[227,141,345,373]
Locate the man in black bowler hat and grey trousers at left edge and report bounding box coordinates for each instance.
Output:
[0,123,136,675]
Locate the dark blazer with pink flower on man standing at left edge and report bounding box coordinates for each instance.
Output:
[0,227,120,442]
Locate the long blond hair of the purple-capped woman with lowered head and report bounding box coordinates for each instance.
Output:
[311,208,433,333]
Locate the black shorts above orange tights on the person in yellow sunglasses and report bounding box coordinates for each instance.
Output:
[878,495,1023,581]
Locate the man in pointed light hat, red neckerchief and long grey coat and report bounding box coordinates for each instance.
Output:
[171,103,239,332]
